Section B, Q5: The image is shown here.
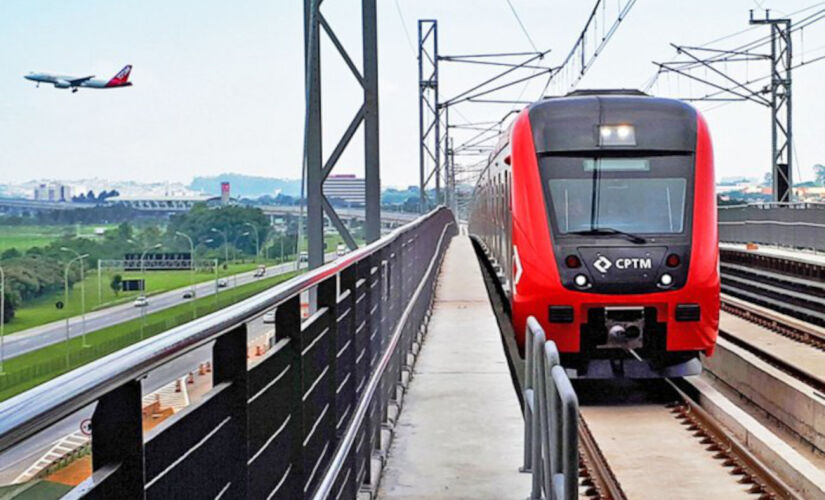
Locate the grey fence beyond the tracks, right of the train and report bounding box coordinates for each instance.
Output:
[719,203,825,251]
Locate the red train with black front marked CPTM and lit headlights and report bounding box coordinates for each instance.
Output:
[469,90,720,378]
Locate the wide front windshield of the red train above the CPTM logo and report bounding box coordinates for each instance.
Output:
[540,155,693,234]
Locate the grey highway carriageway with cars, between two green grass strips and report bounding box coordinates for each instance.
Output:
[4,253,335,359]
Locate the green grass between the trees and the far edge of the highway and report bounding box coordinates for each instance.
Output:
[5,262,284,335]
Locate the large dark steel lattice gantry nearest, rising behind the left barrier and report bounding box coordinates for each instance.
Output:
[303,0,381,268]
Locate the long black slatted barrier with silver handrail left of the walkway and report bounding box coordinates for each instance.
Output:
[0,207,457,499]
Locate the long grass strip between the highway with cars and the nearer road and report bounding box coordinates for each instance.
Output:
[0,272,298,401]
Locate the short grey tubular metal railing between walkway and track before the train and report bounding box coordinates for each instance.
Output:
[522,316,579,500]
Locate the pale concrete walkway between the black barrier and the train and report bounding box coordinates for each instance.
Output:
[378,236,530,499]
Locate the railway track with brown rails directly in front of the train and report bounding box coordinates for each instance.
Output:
[579,379,799,500]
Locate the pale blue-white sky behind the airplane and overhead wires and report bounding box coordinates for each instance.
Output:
[0,0,825,186]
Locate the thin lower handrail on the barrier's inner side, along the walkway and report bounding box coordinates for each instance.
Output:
[313,222,455,500]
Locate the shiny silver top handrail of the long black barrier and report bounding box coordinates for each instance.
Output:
[0,206,447,449]
